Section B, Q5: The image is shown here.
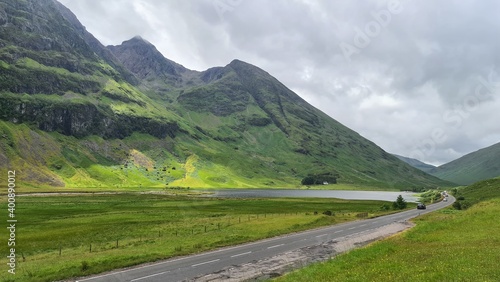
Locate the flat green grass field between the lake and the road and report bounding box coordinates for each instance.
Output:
[0,194,394,282]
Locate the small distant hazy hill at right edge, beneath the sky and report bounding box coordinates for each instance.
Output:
[430,143,500,185]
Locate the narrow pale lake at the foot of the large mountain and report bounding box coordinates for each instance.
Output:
[202,189,419,202]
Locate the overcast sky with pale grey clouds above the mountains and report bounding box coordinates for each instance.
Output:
[59,0,500,165]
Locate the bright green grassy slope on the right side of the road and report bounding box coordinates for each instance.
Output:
[276,179,500,282]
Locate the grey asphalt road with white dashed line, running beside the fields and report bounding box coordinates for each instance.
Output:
[76,196,455,282]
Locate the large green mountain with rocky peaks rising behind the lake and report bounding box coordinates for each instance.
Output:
[0,0,450,190]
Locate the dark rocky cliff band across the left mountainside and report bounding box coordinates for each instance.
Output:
[0,97,179,138]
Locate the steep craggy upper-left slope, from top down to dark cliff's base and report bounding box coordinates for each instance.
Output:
[0,0,183,138]
